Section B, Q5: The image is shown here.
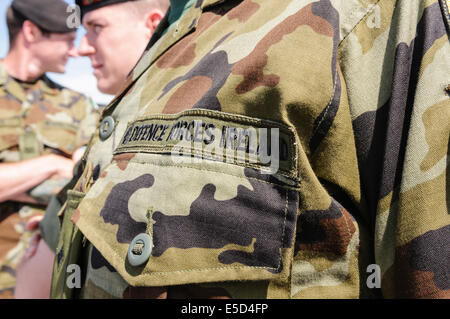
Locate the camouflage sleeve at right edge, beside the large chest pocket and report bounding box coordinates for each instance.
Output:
[339,0,450,298]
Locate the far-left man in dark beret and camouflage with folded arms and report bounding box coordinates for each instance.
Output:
[0,0,98,298]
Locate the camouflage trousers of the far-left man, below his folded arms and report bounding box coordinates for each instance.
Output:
[0,202,45,299]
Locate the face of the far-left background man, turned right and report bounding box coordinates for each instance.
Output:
[33,32,78,73]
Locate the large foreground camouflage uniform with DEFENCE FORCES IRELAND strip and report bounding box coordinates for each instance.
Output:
[52,0,450,298]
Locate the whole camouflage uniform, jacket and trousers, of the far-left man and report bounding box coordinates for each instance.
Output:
[0,62,98,297]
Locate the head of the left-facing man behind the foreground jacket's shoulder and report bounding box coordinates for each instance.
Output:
[77,0,169,95]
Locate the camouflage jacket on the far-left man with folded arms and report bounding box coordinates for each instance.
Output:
[0,61,99,205]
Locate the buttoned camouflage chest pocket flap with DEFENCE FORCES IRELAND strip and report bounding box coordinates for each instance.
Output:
[72,110,298,286]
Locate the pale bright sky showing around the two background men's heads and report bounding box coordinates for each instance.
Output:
[0,0,112,104]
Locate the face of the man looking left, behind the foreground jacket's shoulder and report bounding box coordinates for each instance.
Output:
[78,5,153,94]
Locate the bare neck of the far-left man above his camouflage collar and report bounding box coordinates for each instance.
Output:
[3,49,45,82]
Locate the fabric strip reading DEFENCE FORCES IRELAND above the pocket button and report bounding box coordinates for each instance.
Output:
[114,110,297,177]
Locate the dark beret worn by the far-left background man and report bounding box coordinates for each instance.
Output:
[11,0,76,33]
